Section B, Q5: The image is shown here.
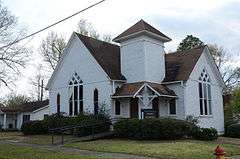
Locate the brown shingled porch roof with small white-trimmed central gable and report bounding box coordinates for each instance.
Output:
[112,81,177,98]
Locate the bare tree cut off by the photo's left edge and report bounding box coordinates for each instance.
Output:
[0,1,29,86]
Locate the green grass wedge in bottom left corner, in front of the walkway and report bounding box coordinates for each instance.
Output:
[0,144,105,159]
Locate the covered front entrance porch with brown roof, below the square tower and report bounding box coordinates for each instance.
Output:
[112,82,177,119]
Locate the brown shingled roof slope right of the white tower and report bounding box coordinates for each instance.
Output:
[163,46,205,82]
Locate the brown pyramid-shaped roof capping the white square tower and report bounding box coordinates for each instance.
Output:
[113,19,171,42]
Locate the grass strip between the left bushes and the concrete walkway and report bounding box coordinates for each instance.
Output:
[0,132,74,145]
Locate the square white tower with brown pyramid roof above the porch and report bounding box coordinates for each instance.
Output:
[113,20,171,83]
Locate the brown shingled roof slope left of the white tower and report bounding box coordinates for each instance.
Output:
[76,33,125,80]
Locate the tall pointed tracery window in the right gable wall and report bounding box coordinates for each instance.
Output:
[198,69,212,115]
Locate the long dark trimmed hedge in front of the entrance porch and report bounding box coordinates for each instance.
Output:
[114,118,195,140]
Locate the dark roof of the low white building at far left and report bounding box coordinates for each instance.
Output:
[0,100,49,113]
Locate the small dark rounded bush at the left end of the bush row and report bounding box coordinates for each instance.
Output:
[21,121,48,135]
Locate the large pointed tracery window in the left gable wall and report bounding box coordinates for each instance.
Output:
[68,73,83,116]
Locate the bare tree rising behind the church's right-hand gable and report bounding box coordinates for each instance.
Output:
[208,44,240,92]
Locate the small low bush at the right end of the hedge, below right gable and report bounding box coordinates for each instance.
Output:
[192,127,218,140]
